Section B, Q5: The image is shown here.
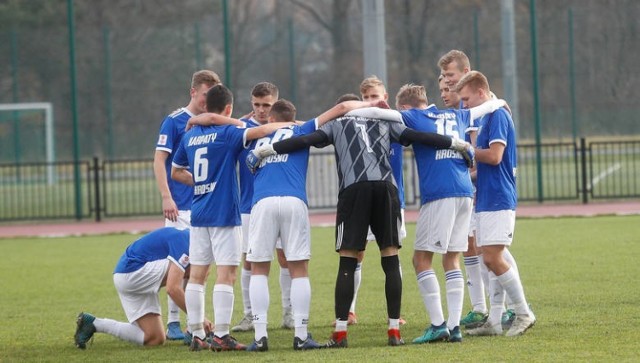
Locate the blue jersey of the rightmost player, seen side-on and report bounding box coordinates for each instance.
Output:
[476,108,518,212]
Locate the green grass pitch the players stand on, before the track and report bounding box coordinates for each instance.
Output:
[0,216,640,362]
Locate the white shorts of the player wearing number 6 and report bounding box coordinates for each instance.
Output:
[189,226,242,266]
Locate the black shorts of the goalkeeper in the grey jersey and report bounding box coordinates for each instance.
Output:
[335,181,402,251]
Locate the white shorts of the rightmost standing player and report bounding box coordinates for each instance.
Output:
[476,209,516,247]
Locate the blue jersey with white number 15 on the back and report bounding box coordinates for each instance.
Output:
[400,105,473,204]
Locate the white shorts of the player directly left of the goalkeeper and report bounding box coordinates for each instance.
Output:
[247,197,311,262]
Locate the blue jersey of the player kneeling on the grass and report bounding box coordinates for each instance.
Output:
[113,227,189,273]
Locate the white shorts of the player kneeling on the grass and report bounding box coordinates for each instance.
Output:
[113,259,170,323]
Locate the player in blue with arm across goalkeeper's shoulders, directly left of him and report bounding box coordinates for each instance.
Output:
[247,100,378,351]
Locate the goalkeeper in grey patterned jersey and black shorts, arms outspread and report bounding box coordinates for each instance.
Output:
[247,104,470,348]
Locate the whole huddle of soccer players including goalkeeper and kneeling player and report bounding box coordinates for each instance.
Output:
[74,50,536,352]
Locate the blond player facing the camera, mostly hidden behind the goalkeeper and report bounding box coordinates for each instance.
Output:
[340,76,407,325]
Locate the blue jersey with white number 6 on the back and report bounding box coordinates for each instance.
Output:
[173,125,247,227]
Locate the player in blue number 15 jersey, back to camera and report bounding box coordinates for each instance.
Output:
[348,84,505,344]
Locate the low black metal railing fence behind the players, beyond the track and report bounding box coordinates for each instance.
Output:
[0,139,640,222]
